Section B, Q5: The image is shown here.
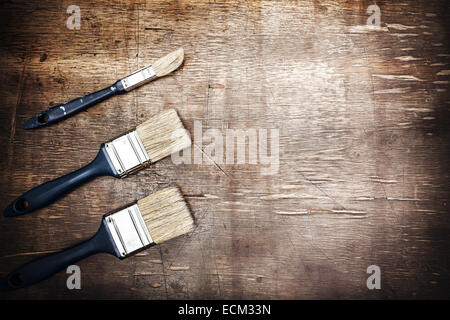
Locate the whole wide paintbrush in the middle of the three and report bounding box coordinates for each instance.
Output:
[3,109,191,217]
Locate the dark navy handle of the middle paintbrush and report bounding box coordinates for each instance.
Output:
[3,144,118,217]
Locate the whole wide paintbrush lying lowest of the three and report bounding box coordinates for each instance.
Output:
[0,187,194,290]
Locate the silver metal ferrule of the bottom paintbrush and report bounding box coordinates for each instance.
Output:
[105,204,153,258]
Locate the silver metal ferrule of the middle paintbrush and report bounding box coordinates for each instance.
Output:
[105,131,150,178]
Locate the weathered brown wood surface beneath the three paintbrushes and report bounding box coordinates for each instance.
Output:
[0,0,450,299]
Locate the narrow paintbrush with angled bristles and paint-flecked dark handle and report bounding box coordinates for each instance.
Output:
[23,48,184,129]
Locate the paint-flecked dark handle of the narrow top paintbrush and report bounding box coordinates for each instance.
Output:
[23,80,125,129]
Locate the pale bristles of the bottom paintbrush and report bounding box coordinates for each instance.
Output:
[137,187,194,244]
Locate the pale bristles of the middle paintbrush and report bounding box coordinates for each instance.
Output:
[136,109,191,162]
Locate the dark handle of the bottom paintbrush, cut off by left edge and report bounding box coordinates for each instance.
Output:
[0,220,116,290]
